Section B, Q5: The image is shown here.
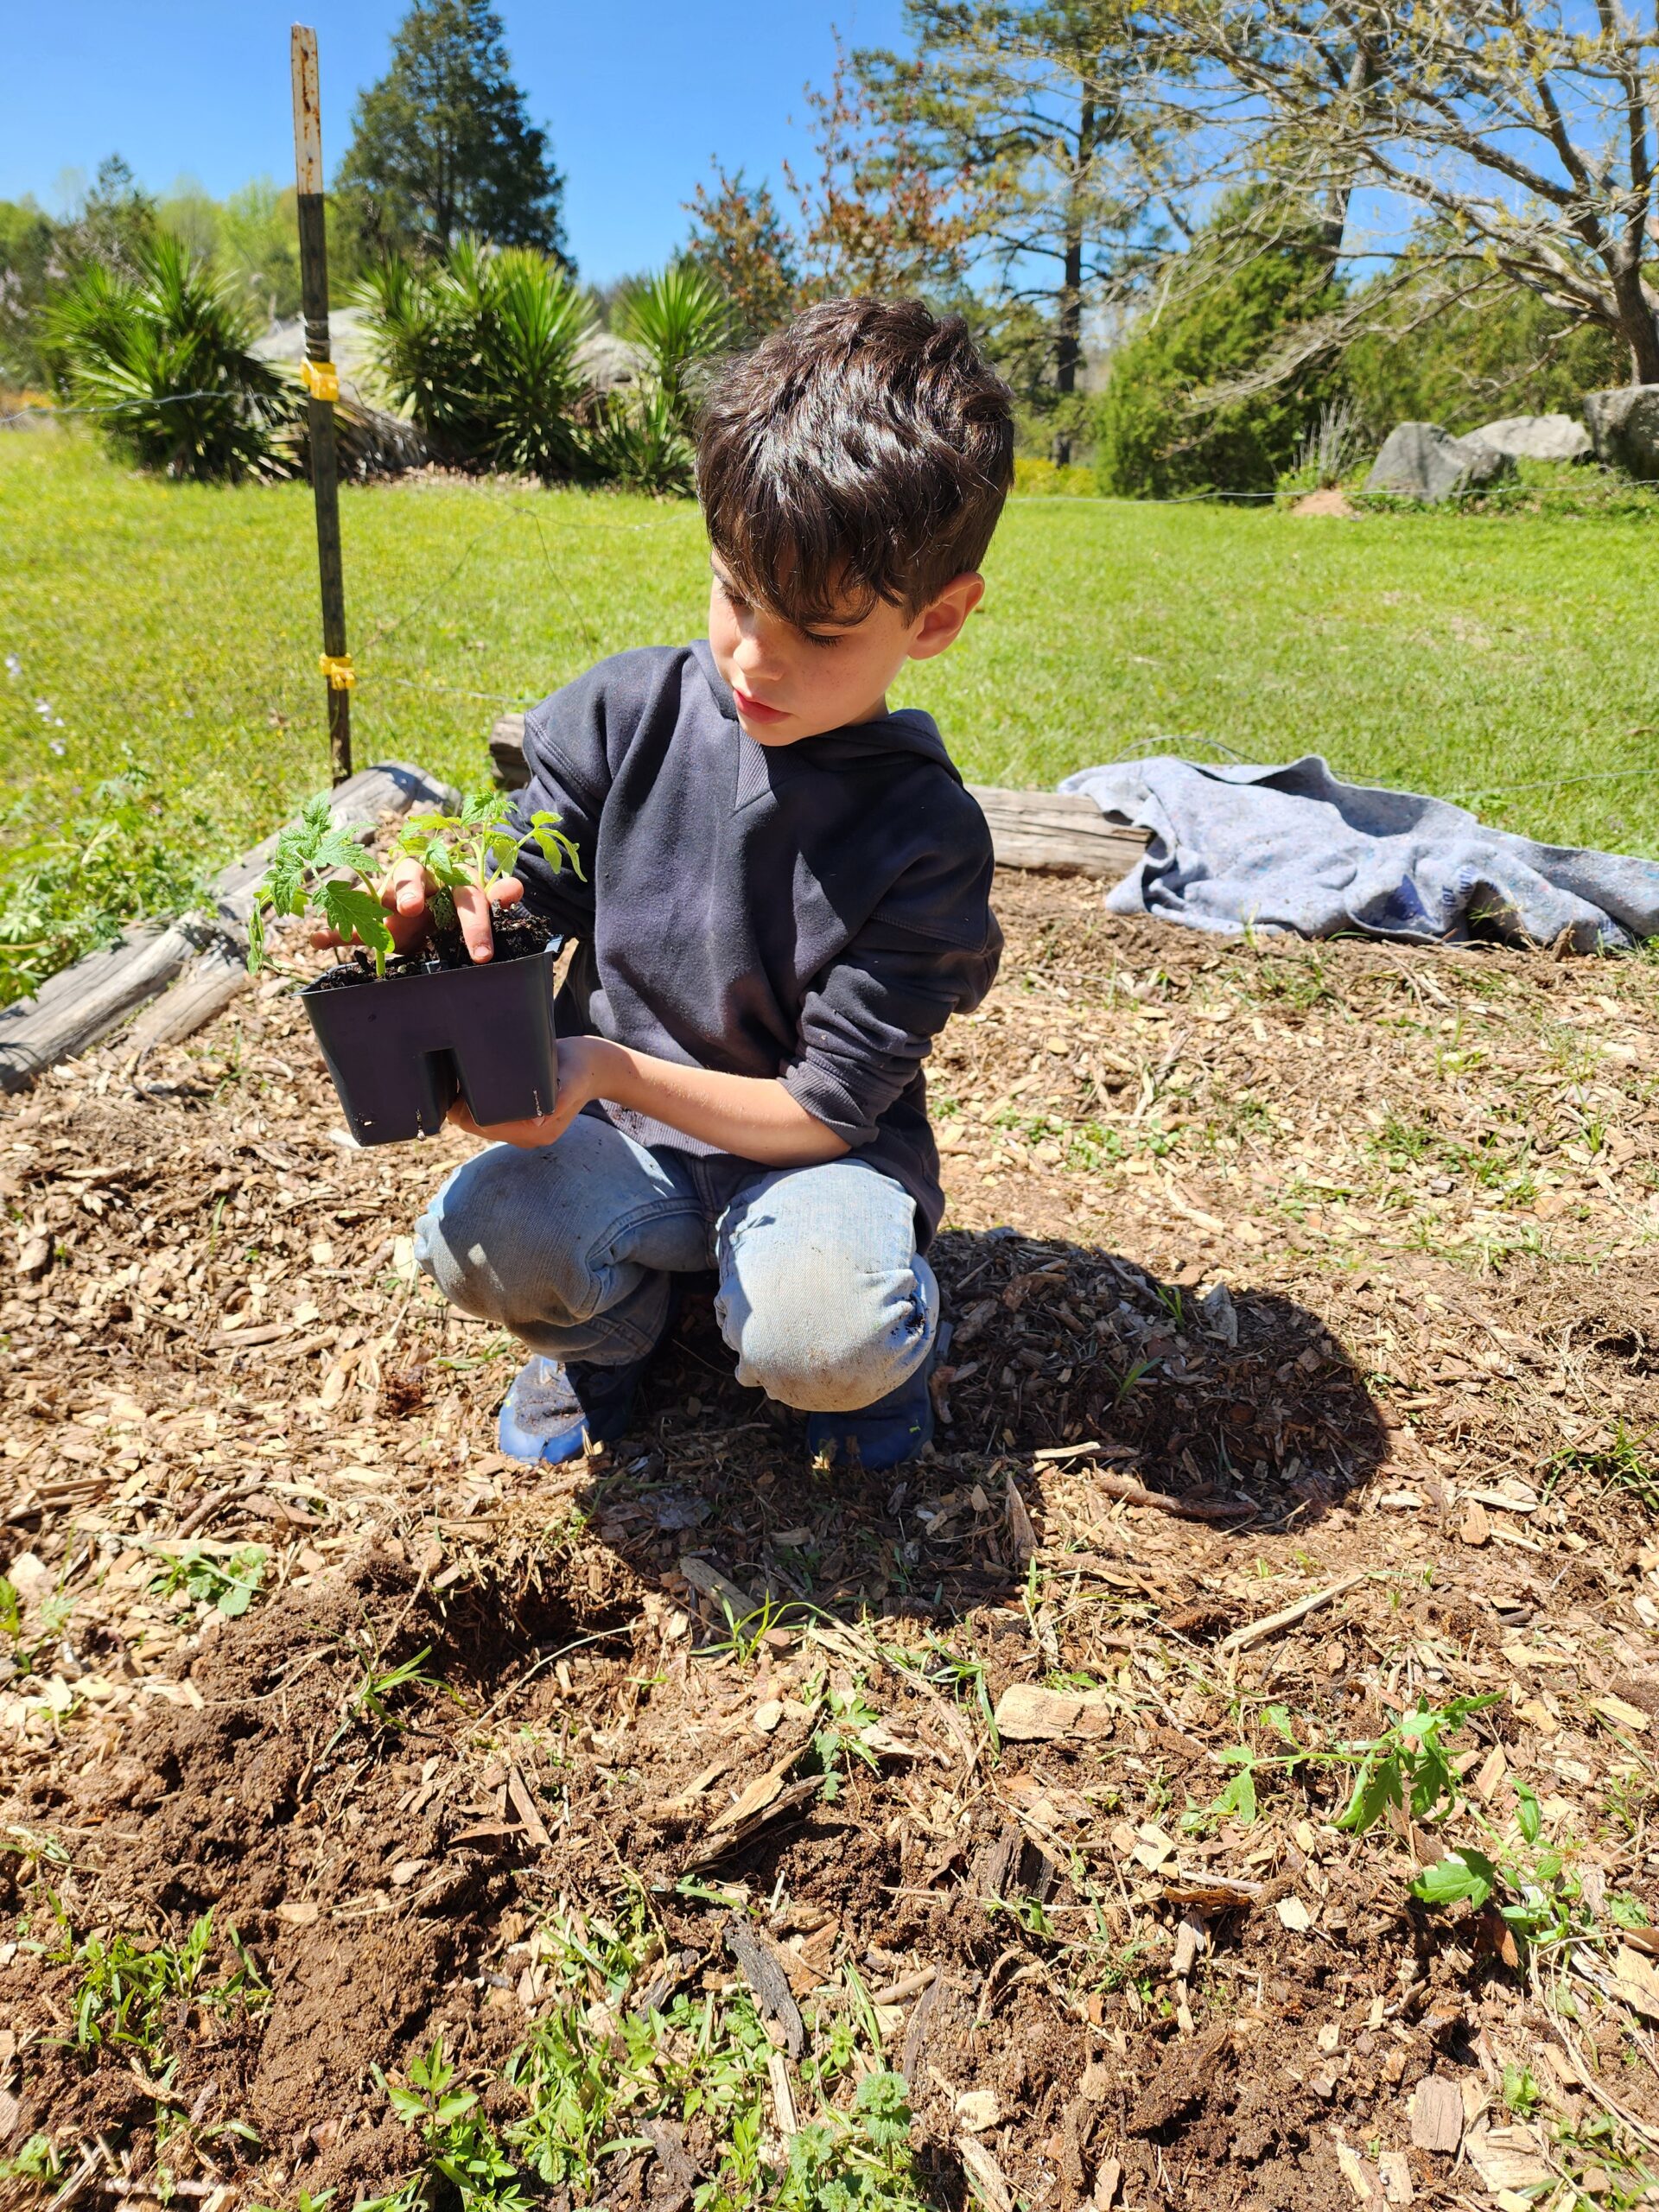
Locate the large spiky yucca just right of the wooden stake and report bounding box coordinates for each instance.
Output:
[359,237,593,482]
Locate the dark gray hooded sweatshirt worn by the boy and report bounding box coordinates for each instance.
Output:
[518,639,1002,1241]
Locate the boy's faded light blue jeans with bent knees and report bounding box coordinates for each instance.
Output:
[414,1115,938,1414]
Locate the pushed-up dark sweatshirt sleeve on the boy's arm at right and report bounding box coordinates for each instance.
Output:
[781,818,1002,1150]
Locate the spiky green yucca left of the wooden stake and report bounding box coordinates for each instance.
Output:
[47,230,299,482]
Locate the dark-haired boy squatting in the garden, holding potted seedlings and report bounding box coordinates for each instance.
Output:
[402,299,1013,1469]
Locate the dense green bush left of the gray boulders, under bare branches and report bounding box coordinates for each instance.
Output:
[1095,197,1338,500]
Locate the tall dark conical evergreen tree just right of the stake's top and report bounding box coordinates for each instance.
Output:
[334,0,570,268]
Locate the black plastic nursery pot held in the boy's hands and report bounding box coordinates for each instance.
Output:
[299,940,560,1144]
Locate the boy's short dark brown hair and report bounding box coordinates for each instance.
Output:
[696,299,1013,624]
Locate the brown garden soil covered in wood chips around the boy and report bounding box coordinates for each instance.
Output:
[0,878,1659,2212]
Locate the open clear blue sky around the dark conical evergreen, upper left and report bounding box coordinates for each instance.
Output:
[0,0,900,283]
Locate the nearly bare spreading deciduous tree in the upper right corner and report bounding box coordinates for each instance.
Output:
[1170,0,1659,383]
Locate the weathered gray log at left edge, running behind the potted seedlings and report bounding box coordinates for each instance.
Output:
[0,761,455,1090]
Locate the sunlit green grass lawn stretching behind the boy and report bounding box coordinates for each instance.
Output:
[0,434,1659,995]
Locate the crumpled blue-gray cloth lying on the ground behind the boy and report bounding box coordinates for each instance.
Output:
[1059,752,1659,953]
